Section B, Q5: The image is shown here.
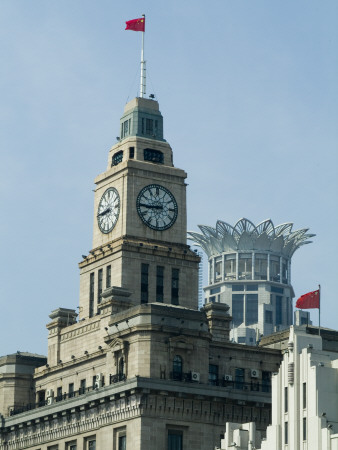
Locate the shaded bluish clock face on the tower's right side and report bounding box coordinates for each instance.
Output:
[136,184,178,231]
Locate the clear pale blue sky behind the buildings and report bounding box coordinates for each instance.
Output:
[0,0,338,355]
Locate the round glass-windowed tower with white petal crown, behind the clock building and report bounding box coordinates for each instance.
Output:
[188,219,314,345]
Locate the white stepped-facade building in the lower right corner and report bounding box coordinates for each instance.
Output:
[215,326,338,450]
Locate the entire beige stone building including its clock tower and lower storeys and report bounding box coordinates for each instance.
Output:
[0,98,283,450]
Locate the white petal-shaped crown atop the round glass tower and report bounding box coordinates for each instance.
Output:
[188,218,315,258]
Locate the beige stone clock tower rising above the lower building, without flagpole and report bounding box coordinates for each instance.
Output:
[80,98,199,319]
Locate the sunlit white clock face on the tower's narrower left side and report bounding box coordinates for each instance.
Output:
[97,188,120,233]
